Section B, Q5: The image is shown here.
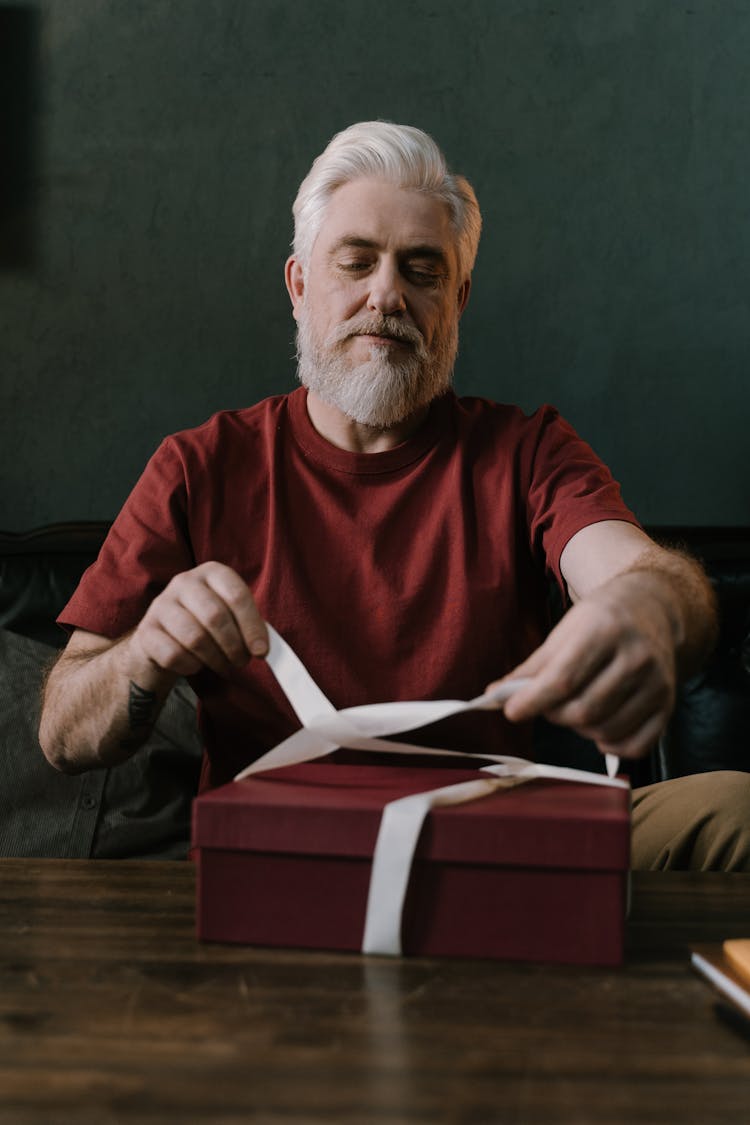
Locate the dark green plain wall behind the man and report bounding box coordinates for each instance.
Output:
[0,0,750,530]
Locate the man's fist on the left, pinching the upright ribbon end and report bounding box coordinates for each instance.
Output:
[129,563,269,676]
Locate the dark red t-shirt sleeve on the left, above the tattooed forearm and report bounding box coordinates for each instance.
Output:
[57,438,196,639]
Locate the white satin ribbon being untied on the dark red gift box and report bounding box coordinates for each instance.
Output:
[235,626,629,956]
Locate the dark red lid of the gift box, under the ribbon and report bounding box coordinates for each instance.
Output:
[192,763,630,871]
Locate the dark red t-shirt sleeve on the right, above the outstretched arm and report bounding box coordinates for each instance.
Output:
[526,406,640,588]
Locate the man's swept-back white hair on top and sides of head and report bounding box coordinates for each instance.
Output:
[292,122,481,280]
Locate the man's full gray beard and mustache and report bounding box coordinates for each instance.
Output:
[297,309,459,430]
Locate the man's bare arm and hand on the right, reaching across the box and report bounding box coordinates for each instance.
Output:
[494,521,717,758]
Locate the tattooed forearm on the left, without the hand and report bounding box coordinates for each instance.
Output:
[39,635,177,773]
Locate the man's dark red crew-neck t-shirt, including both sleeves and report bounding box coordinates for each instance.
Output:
[60,388,636,788]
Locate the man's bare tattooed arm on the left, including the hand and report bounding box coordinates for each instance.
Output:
[39,563,268,773]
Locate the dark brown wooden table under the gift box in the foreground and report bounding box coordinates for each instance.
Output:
[0,860,750,1125]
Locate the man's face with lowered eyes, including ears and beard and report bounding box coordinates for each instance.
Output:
[287,179,469,429]
